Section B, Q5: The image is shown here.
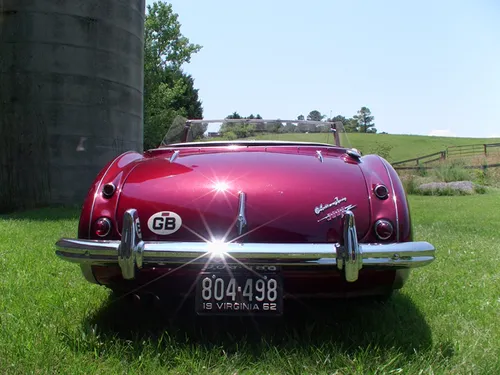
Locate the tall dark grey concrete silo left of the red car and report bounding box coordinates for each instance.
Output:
[0,0,145,212]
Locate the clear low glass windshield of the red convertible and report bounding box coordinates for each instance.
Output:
[160,116,351,148]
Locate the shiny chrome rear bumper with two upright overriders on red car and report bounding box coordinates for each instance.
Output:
[56,209,435,282]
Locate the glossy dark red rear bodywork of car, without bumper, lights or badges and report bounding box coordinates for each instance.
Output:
[78,145,412,296]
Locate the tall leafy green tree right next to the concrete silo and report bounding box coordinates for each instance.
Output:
[144,2,203,149]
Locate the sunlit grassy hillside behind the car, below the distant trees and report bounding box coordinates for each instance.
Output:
[223,133,500,162]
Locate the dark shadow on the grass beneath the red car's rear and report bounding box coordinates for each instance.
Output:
[78,293,432,356]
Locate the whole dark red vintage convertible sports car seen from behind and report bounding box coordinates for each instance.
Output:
[56,119,435,315]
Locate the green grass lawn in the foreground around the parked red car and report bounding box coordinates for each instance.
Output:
[0,194,500,374]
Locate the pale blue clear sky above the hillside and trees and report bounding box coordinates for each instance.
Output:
[147,0,500,137]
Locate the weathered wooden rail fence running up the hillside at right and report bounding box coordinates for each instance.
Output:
[391,143,500,169]
